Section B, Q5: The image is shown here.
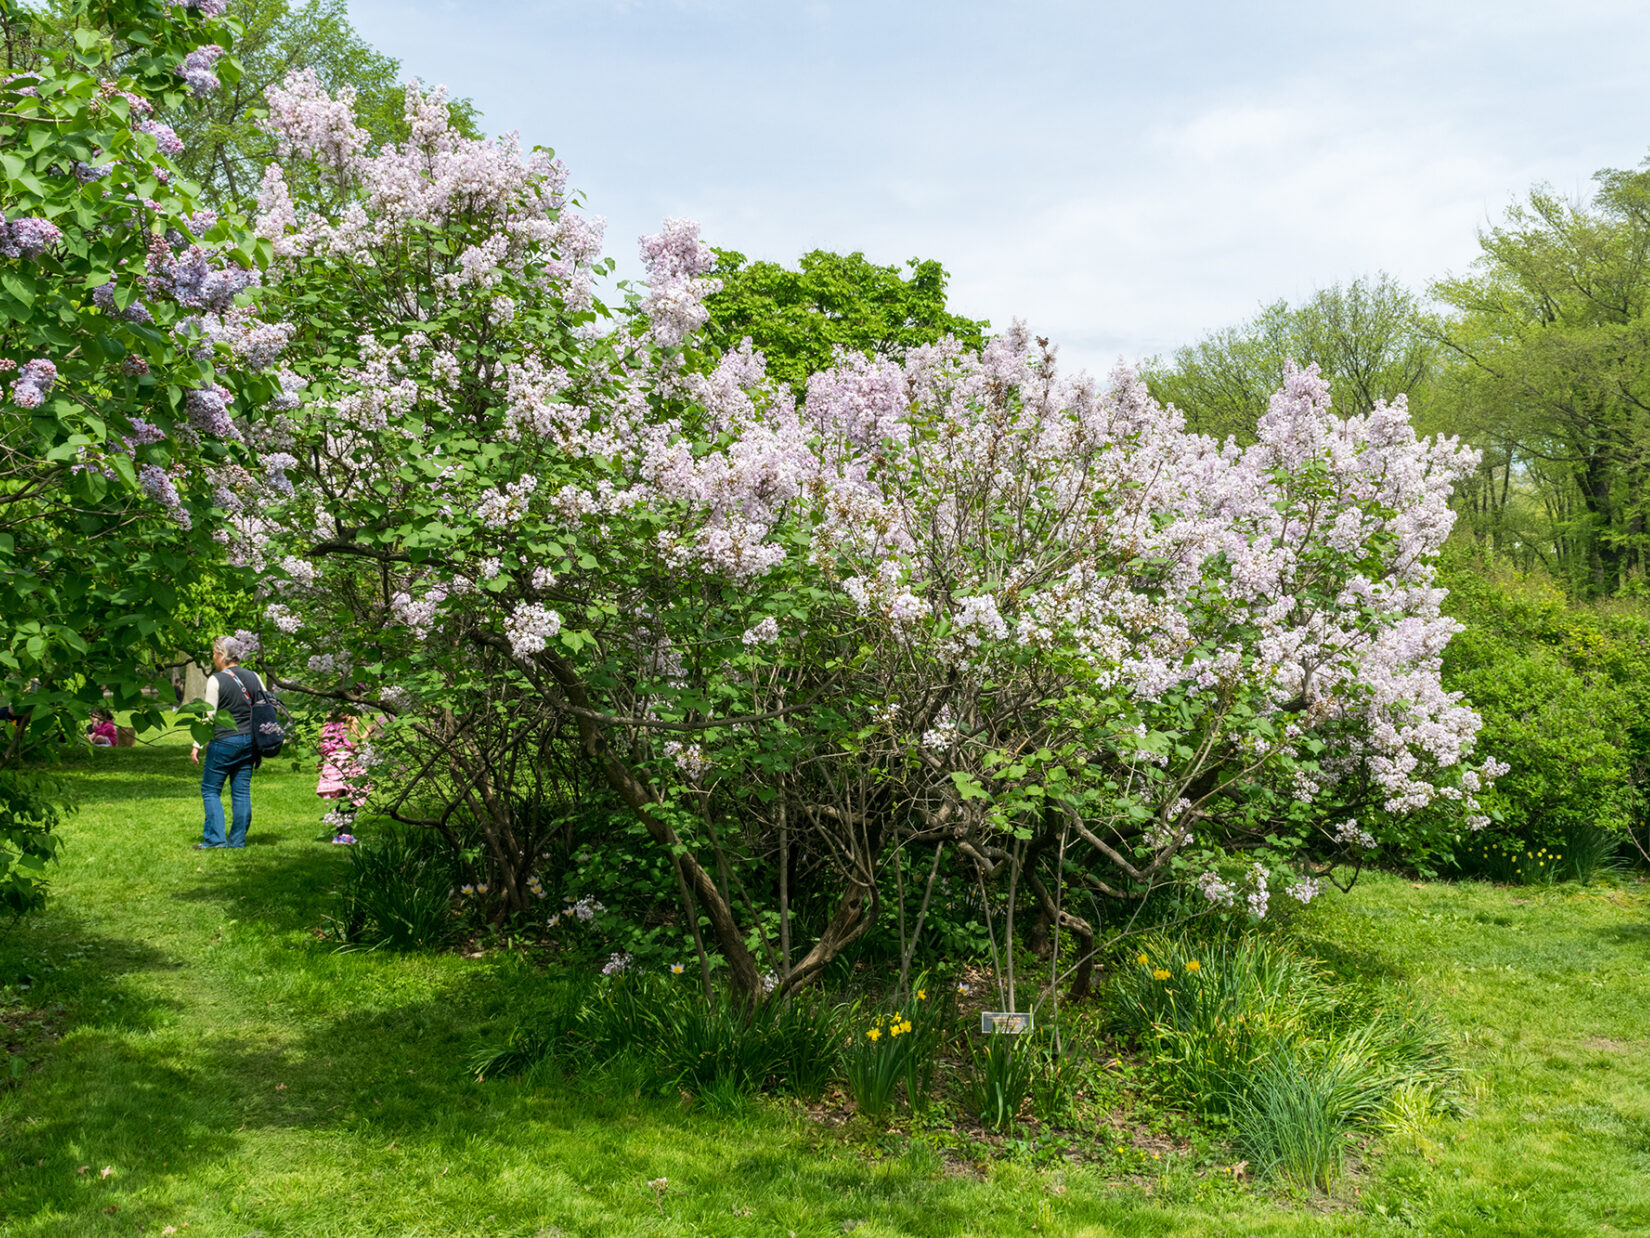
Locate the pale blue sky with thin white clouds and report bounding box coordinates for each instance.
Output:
[350,0,1650,373]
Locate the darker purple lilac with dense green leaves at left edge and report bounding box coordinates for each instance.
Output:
[0,0,293,746]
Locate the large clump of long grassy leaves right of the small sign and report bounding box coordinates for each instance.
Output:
[1112,934,1455,1190]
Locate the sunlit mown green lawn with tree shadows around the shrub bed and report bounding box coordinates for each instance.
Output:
[0,746,1650,1238]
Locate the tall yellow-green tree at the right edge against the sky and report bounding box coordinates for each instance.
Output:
[1434,162,1650,596]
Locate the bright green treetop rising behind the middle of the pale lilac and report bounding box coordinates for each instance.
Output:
[706,249,990,386]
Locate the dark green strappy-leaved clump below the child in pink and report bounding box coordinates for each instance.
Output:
[332,830,459,951]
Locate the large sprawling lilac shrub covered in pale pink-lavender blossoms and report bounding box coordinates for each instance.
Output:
[250,73,1495,994]
